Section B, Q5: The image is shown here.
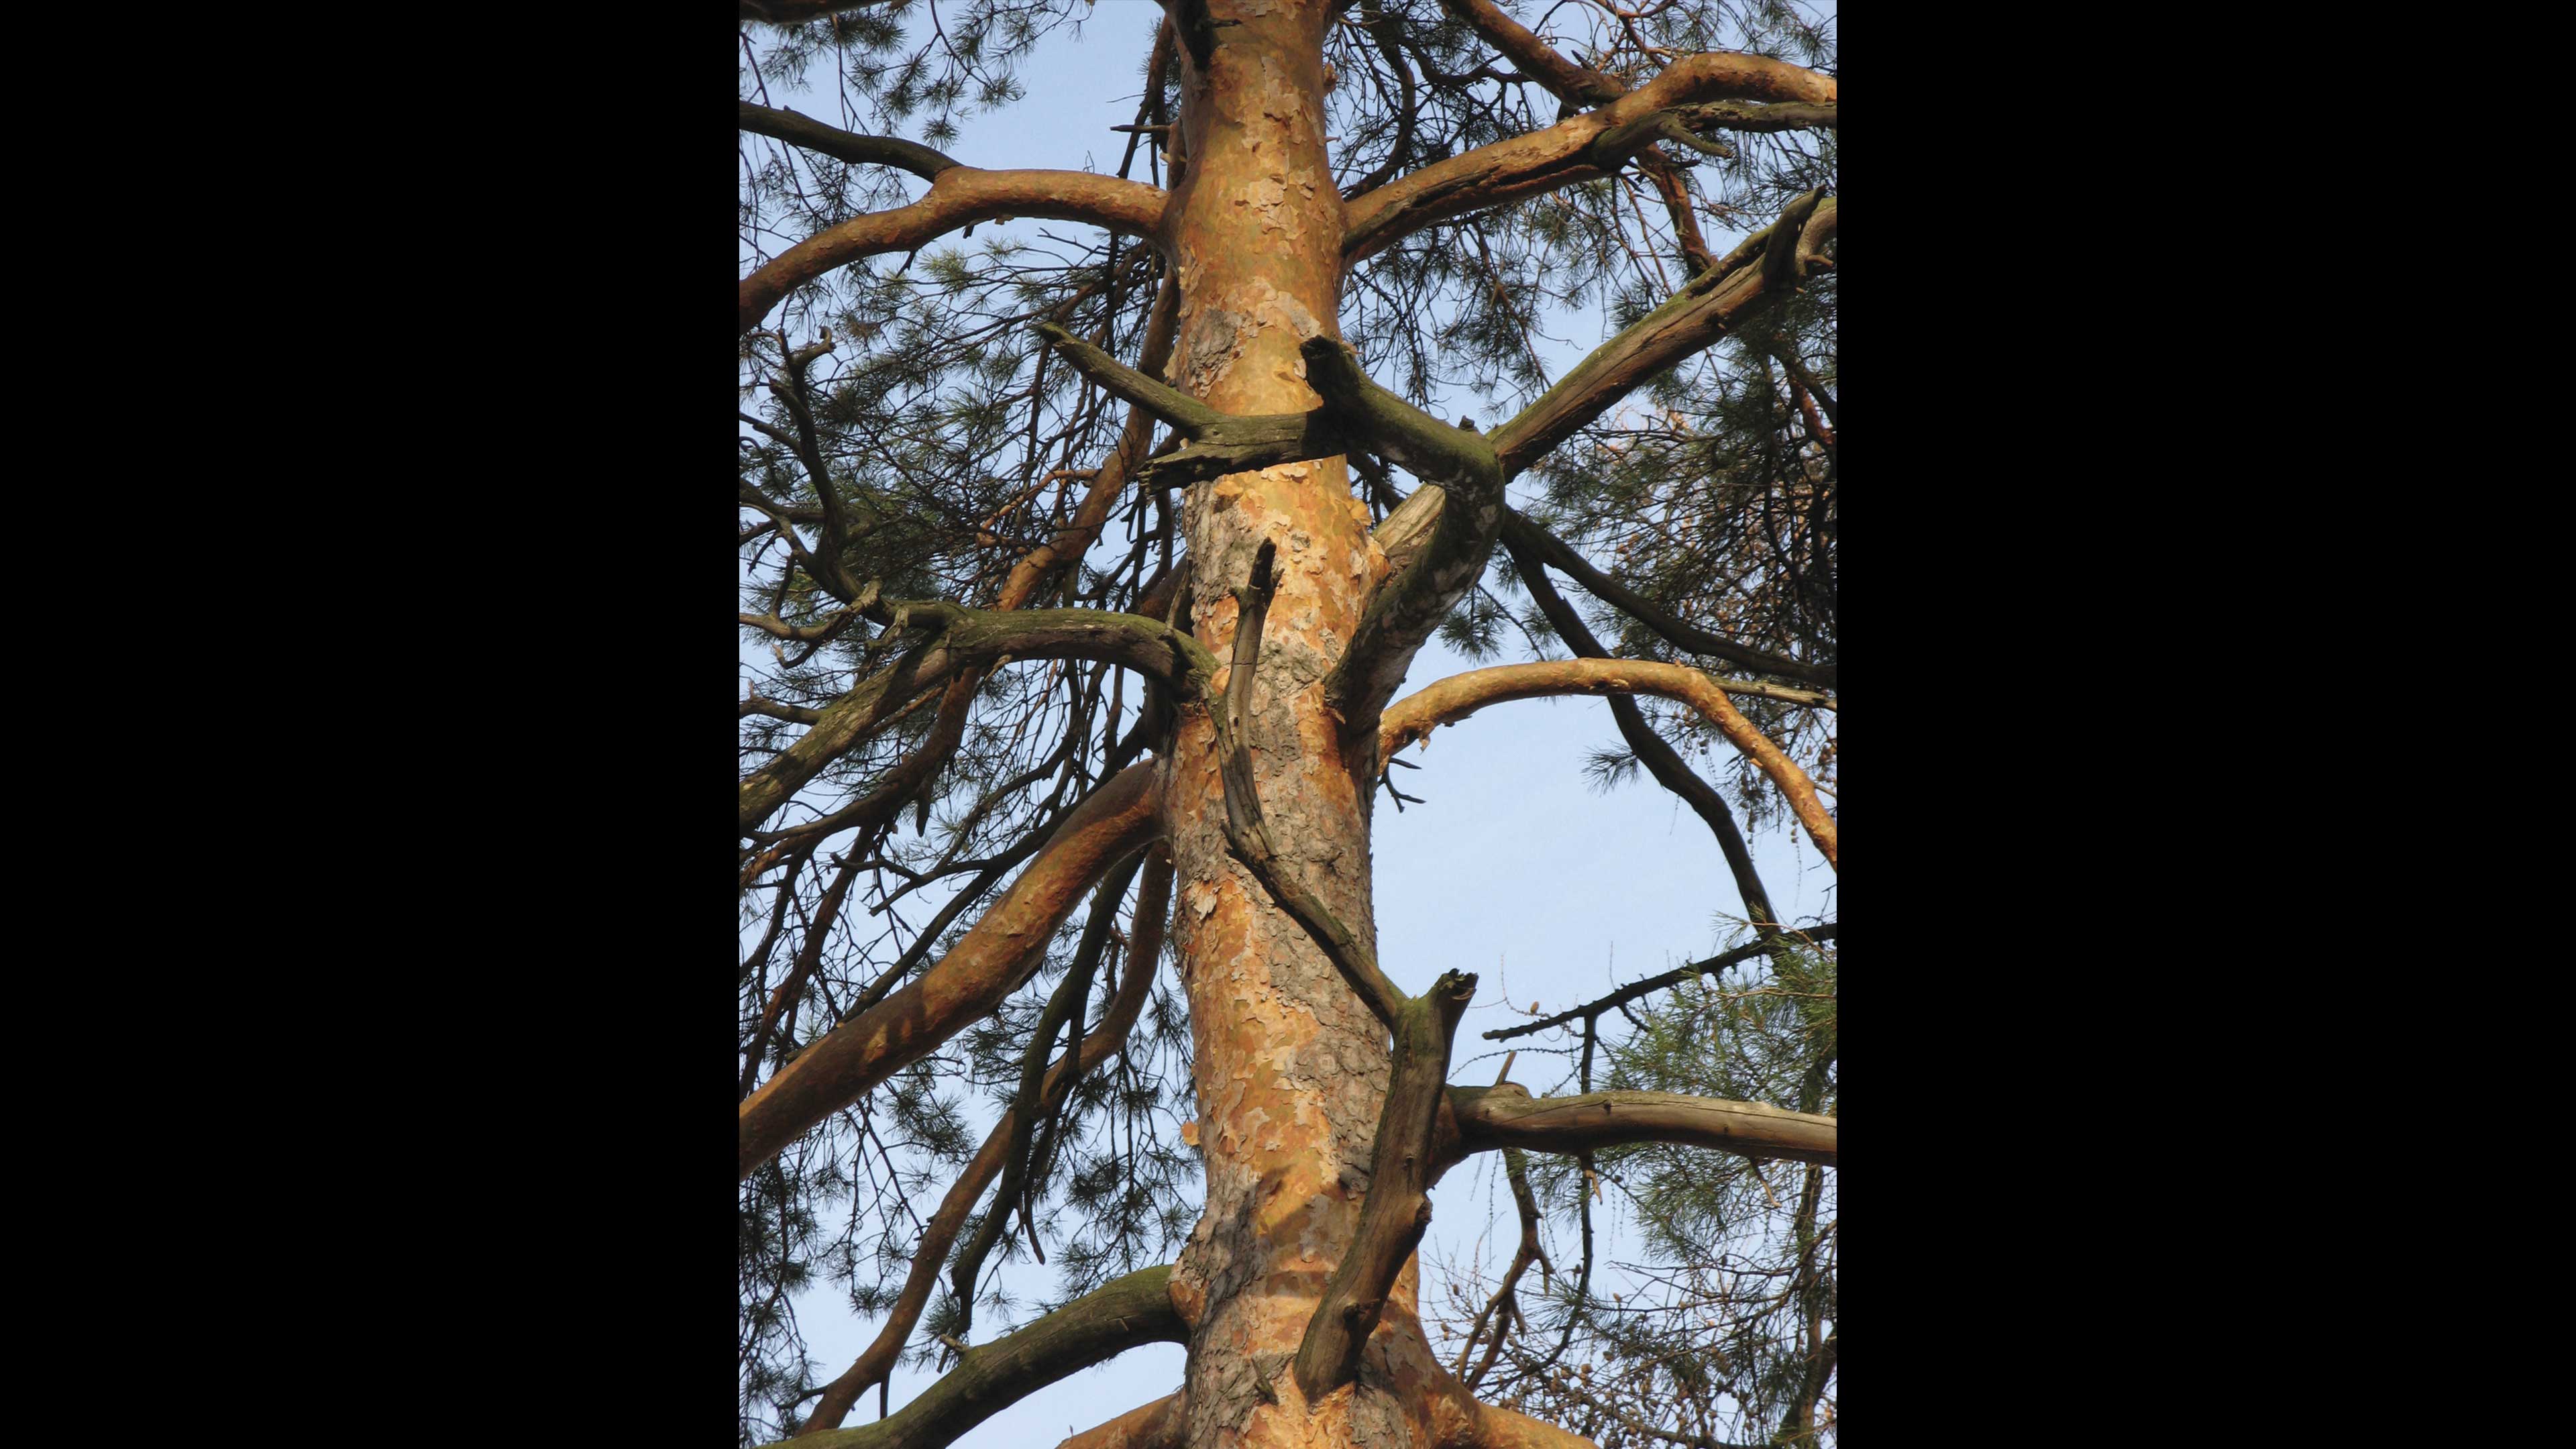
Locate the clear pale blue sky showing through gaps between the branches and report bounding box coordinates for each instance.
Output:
[734,0,1839,1449]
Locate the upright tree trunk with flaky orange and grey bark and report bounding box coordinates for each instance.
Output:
[1165,0,1473,1449]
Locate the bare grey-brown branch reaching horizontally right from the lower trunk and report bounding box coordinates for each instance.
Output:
[1440,1083,1839,1168]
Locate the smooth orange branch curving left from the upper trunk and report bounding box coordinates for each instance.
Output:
[734,165,1169,333]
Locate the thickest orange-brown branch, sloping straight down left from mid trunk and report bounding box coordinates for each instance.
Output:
[739,765,1159,1176]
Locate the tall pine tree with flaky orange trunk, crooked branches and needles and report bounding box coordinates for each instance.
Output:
[737,0,1839,1449]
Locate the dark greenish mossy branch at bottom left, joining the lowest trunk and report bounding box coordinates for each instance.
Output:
[798,1266,1187,1449]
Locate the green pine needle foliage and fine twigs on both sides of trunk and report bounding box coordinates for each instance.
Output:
[737,0,1839,1449]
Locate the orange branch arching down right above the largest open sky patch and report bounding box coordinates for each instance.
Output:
[1378,660,1842,871]
